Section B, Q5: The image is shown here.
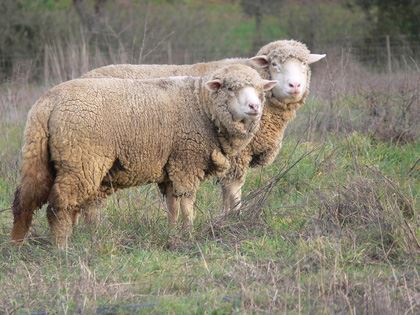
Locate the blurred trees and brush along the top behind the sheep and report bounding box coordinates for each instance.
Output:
[0,0,420,79]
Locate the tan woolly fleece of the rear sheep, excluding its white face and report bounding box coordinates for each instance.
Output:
[83,40,311,186]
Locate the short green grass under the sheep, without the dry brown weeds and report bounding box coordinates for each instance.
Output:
[0,113,420,314]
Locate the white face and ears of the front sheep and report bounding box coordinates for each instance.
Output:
[206,79,277,121]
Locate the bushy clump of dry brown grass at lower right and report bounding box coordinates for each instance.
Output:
[308,168,420,263]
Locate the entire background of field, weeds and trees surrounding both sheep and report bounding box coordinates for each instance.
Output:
[0,0,420,314]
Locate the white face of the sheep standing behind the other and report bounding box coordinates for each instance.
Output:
[269,58,309,103]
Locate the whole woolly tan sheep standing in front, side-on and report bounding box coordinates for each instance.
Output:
[11,65,277,247]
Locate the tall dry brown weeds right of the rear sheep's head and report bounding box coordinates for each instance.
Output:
[289,49,420,144]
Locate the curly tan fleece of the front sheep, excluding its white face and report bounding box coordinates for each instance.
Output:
[15,65,262,208]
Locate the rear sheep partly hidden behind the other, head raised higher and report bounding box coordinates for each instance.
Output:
[83,40,325,211]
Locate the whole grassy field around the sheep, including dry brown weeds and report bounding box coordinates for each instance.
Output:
[0,66,420,314]
